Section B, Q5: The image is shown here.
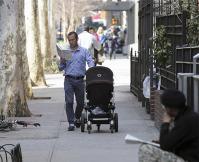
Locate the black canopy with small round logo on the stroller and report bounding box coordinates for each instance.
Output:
[86,66,113,86]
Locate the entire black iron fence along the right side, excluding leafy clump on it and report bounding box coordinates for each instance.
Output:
[131,0,199,111]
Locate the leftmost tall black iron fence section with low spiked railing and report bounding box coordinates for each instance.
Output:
[131,0,153,109]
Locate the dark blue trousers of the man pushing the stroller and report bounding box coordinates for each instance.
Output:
[64,77,85,124]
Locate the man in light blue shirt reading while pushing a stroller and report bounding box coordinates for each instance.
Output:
[59,32,94,131]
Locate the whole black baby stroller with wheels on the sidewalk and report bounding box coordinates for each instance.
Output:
[81,66,118,134]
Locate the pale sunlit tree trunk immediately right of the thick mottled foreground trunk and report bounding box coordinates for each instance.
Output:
[25,0,46,86]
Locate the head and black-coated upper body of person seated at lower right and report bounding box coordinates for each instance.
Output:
[160,89,199,162]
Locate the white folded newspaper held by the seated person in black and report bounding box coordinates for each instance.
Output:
[125,134,160,147]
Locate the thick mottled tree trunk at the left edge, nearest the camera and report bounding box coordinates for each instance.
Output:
[0,0,31,116]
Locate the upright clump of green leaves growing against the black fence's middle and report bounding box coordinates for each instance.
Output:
[153,25,172,67]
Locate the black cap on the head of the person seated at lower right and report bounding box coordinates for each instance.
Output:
[160,89,186,109]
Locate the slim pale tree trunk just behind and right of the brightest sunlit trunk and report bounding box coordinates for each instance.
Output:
[38,0,52,69]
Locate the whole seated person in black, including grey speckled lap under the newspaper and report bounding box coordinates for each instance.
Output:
[139,89,199,162]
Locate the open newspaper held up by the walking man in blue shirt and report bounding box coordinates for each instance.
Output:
[56,42,72,60]
